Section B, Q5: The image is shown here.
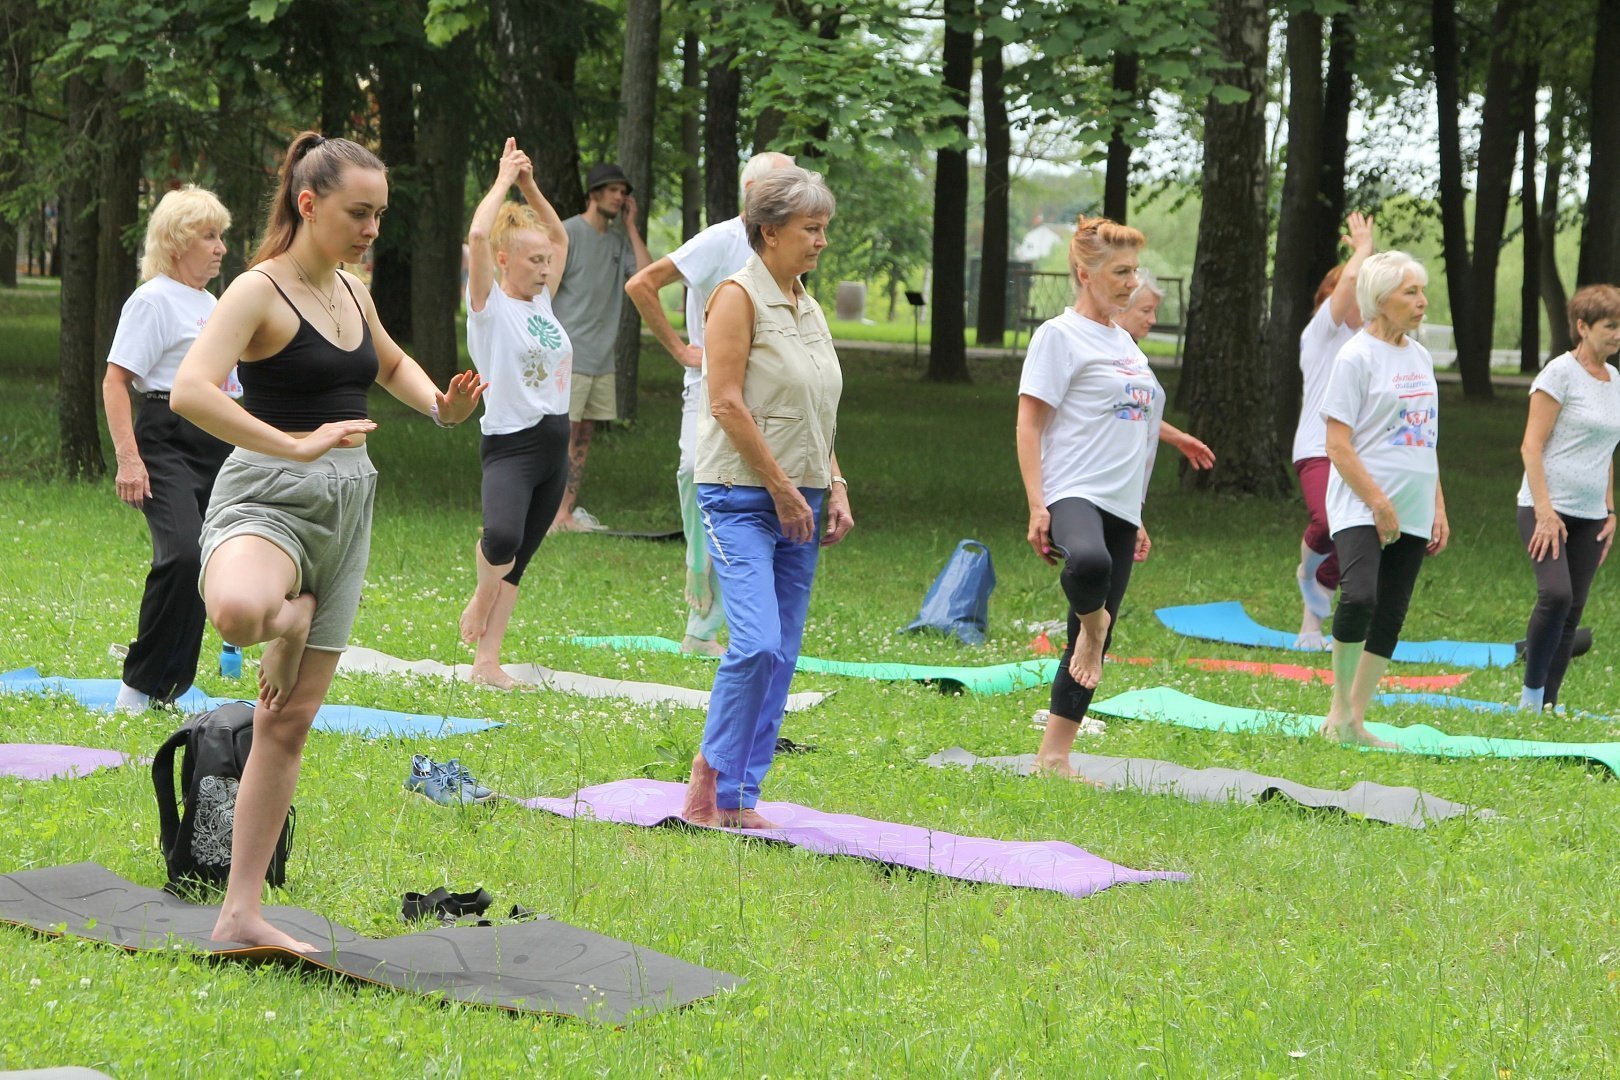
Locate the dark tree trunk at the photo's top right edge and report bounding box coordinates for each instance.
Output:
[1575,0,1620,287]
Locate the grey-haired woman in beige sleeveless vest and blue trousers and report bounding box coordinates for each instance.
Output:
[682,167,855,829]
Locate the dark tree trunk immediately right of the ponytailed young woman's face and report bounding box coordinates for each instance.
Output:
[371,57,423,343]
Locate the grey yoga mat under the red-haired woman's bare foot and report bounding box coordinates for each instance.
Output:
[925,746,1495,829]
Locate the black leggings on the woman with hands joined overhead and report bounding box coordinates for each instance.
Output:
[478,413,569,585]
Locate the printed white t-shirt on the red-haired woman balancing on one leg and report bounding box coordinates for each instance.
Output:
[1017,308,1165,525]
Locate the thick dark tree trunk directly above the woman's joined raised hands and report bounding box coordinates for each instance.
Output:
[489,0,585,219]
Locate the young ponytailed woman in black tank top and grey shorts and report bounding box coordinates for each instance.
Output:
[170,131,484,952]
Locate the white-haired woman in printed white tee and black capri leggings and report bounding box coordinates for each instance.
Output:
[1322,251,1450,748]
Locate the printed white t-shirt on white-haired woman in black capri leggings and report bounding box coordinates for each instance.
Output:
[1322,330,1440,539]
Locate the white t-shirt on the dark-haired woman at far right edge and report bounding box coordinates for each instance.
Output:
[1518,353,1620,520]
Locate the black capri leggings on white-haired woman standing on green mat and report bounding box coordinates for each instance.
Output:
[1333,525,1429,659]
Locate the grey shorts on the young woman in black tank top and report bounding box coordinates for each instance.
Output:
[198,447,377,653]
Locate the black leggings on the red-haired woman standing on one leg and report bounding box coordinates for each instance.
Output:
[1047,499,1136,724]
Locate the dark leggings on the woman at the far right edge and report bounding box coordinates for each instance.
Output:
[1518,507,1607,704]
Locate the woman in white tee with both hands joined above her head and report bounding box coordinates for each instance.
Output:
[462,139,573,690]
